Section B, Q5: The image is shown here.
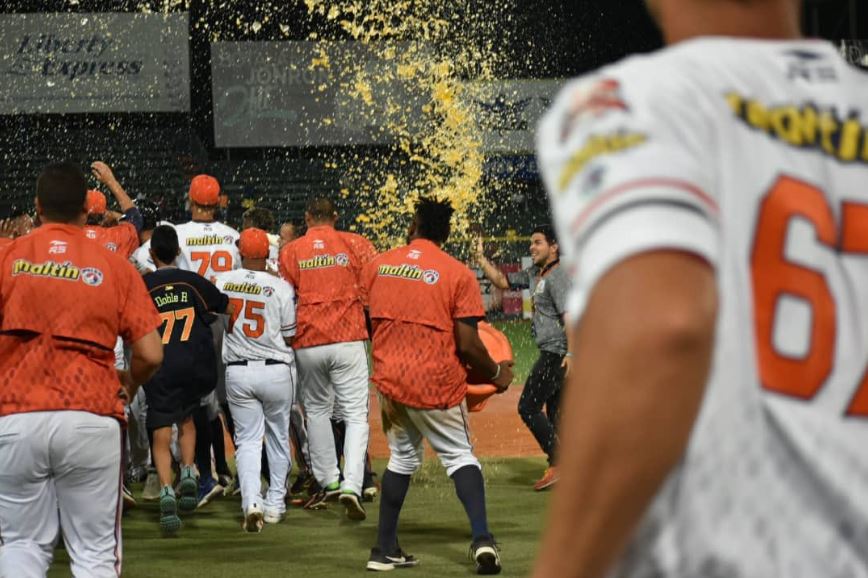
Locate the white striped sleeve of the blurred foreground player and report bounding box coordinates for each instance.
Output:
[537,62,723,315]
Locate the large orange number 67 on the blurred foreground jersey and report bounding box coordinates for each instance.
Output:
[751,177,868,417]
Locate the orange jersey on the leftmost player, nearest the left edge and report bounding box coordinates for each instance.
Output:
[0,224,161,420]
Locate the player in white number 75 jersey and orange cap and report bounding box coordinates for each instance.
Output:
[217,228,296,532]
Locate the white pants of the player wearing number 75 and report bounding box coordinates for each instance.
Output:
[226,361,295,514]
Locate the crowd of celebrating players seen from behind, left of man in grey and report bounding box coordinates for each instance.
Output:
[0,162,512,576]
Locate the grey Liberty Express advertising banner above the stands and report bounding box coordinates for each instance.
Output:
[0,13,190,114]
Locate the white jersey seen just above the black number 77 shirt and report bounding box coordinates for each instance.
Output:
[175,221,241,281]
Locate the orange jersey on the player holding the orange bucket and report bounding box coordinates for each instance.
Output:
[362,239,485,409]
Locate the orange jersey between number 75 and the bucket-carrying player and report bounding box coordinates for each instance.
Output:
[279,226,377,348]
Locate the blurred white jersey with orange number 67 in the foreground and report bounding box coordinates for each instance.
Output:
[537,38,868,578]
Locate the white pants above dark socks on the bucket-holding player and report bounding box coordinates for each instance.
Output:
[380,395,482,476]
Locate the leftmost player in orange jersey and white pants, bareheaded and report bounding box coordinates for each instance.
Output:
[0,163,163,578]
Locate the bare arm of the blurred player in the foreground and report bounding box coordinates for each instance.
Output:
[534,251,717,578]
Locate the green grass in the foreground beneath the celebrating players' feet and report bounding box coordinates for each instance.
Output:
[49,459,548,578]
